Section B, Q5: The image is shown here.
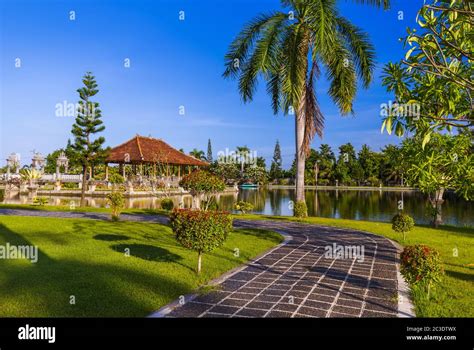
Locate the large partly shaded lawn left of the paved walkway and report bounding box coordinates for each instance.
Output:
[0,216,282,317]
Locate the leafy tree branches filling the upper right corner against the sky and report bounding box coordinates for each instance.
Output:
[382,0,474,145]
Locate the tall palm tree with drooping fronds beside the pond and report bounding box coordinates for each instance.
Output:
[223,0,388,215]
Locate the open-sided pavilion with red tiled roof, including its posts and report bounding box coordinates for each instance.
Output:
[105,135,209,176]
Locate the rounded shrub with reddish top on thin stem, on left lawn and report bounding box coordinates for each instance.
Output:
[170,209,232,273]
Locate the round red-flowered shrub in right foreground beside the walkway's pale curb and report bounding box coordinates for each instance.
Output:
[400,244,444,297]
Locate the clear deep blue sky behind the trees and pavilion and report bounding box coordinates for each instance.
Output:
[0,0,422,167]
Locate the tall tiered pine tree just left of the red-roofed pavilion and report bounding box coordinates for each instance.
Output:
[71,72,106,207]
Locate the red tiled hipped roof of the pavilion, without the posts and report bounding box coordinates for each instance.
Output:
[106,135,209,166]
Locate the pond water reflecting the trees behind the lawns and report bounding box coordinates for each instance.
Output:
[5,188,474,226]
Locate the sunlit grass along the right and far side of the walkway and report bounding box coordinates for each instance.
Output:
[235,215,474,317]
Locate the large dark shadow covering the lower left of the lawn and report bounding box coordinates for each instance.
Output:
[0,224,194,317]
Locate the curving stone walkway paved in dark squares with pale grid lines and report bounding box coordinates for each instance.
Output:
[164,220,404,317]
